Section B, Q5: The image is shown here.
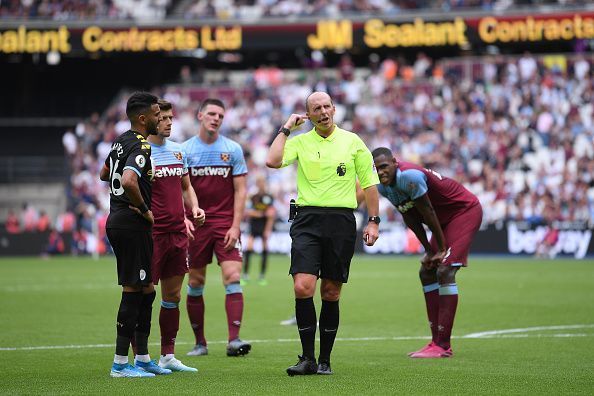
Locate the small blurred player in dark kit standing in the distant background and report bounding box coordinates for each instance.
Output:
[242,176,275,286]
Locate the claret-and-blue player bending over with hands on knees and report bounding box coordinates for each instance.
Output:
[372,147,483,358]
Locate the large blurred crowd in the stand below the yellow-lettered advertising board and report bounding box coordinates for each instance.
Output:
[5,54,594,254]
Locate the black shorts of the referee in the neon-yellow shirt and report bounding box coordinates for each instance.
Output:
[289,206,357,283]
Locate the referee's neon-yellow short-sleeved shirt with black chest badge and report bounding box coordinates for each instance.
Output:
[281,126,379,209]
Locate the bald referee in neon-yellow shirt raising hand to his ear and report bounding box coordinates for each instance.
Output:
[266,92,380,376]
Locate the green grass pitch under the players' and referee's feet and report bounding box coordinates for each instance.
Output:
[0,256,594,395]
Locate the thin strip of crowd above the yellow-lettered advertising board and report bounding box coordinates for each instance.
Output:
[0,0,588,21]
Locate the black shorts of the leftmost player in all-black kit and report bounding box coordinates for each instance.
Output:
[106,228,153,286]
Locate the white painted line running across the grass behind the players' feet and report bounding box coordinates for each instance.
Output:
[0,324,594,352]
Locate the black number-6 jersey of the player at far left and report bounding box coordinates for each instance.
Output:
[105,131,153,231]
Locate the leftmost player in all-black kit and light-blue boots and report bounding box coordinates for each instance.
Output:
[100,92,171,377]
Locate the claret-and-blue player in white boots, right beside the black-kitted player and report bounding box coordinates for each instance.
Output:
[148,99,205,372]
